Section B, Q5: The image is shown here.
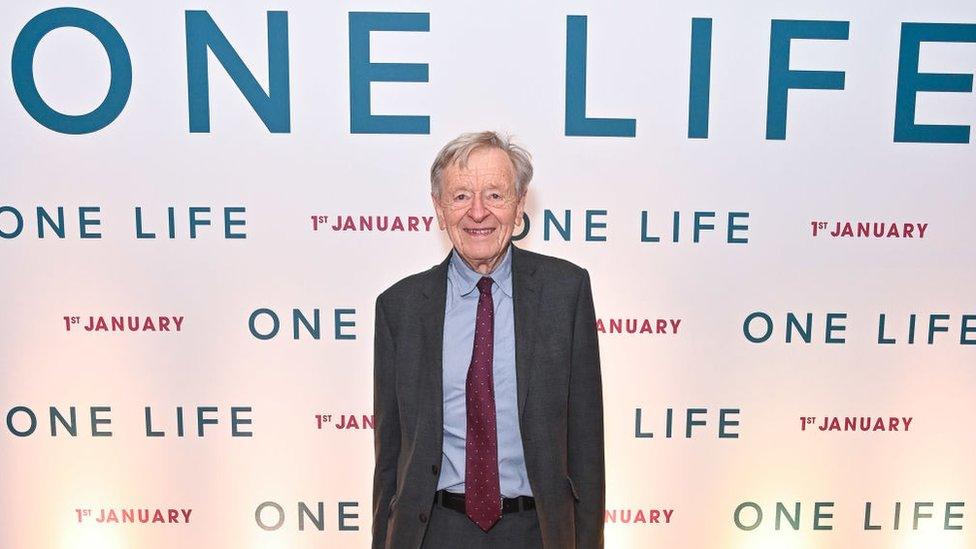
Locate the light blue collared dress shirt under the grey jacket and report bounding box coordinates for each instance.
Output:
[437,245,532,498]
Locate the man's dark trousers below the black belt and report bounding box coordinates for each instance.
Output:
[421,503,542,549]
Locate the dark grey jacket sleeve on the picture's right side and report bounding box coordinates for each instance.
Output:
[567,270,606,549]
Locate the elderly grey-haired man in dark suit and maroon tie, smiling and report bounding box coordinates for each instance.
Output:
[373,132,604,549]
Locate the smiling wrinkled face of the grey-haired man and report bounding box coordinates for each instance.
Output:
[433,147,525,274]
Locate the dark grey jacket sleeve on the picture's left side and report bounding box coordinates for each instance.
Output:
[373,296,400,549]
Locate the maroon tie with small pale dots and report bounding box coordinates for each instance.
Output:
[464,276,502,532]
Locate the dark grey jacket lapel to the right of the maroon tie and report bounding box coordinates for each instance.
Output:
[512,244,542,419]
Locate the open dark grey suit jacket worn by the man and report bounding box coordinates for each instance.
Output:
[373,244,605,549]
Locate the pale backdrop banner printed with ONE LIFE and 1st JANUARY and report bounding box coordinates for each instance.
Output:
[0,0,976,549]
